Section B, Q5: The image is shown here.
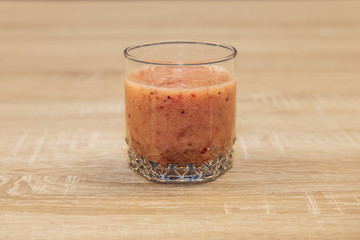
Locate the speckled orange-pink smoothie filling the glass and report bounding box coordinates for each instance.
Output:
[125,66,236,167]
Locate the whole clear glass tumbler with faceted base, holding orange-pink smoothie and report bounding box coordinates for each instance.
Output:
[124,41,237,183]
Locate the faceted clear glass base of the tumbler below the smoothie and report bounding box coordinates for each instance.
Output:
[128,148,233,183]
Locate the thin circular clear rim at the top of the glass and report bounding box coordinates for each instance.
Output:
[124,40,237,66]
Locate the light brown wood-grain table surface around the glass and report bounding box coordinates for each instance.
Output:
[0,1,360,239]
